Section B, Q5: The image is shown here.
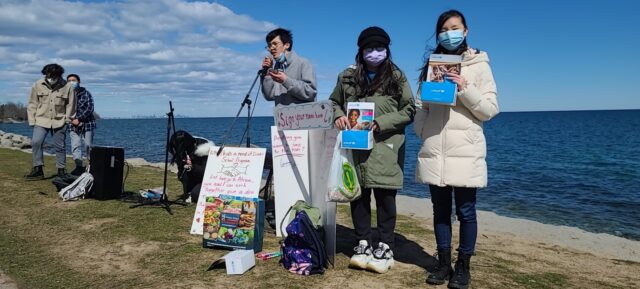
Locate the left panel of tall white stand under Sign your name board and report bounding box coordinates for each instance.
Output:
[271,126,311,237]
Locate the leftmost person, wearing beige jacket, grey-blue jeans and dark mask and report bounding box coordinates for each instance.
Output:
[24,63,76,180]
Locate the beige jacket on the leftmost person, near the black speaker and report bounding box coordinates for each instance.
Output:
[27,79,76,128]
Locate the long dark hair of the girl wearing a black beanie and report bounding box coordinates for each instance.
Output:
[354,45,402,96]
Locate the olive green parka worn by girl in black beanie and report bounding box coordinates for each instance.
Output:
[329,66,415,189]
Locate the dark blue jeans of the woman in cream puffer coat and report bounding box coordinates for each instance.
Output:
[429,185,478,255]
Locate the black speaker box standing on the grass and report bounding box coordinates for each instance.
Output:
[89,146,124,200]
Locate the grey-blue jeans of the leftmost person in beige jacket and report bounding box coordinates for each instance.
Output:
[31,125,67,169]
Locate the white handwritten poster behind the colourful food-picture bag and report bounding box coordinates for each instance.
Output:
[191,147,267,235]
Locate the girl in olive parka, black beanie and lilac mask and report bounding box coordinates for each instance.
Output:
[329,27,415,273]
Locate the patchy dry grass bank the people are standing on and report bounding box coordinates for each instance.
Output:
[0,149,640,288]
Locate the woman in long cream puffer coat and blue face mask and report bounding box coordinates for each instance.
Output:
[414,10,499,288]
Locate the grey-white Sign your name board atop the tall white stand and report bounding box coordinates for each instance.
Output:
[273,101,333,130]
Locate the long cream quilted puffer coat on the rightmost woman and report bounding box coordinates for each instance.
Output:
[414,49,499,188]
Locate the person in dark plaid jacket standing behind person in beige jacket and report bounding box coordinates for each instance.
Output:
[67,74,96,176]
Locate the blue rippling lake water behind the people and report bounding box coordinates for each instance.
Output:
[0,110,640,240]
